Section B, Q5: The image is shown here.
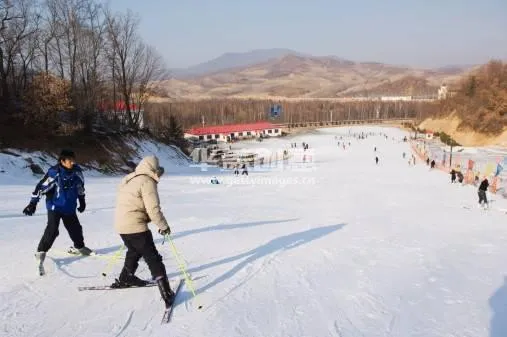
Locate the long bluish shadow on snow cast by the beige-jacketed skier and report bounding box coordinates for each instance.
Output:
[170,224,348,300]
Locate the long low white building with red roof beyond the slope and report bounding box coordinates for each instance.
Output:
[185,122,282,142]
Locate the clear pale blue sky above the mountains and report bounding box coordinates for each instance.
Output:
[110,0,507,68]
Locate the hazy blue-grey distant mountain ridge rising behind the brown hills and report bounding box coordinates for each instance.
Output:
[170,48,305,78]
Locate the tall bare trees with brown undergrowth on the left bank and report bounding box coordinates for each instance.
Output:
[0,0,165,137]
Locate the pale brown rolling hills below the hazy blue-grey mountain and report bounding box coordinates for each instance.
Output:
[156,54,476,99]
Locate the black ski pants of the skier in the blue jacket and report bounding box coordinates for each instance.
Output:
[37,211,84,252]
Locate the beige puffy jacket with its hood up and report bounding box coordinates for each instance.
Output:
[114,156,169,234]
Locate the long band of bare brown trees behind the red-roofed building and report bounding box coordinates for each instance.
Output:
[145,99,436,132]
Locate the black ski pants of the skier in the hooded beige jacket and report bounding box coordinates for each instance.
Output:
[120,230,167,279]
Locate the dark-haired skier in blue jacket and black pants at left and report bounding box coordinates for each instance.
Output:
[23,150,93,275]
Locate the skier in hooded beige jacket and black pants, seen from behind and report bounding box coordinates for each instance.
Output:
[111,156,175,308]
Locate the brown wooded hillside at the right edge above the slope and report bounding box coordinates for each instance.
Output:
[437,61,507,134]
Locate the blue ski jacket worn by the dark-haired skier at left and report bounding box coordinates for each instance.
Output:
[30,164,85,214]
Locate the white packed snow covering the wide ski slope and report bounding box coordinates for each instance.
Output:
[0,127,507,337]
